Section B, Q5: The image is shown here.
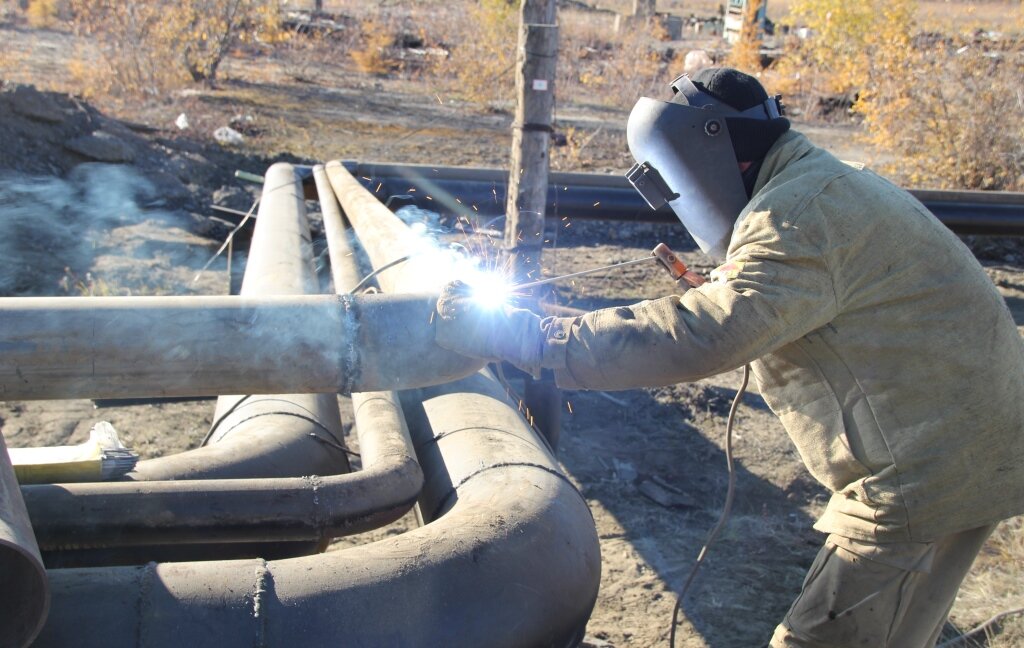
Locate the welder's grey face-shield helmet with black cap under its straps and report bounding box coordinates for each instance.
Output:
[626,69,788,257]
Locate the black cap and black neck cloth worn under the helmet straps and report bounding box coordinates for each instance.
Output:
[690,68,790,162]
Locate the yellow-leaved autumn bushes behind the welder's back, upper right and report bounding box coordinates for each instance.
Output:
[772,0,1024,190]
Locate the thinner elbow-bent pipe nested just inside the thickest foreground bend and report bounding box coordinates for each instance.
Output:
[22,386,423,550]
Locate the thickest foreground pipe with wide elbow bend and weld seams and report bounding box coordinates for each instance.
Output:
[36,373,601,648]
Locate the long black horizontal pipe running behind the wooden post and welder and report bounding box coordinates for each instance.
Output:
[343,161,1024,236]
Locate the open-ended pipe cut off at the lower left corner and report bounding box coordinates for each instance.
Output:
[0,434,50,646]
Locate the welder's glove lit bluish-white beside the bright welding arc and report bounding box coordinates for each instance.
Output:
[434,282,545,375]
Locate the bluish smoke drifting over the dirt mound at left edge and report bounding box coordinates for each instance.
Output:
[0,164,167,296]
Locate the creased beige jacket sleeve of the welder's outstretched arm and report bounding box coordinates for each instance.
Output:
[542,211,838,390]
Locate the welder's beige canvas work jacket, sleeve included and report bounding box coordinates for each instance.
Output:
[542,131,1024,543]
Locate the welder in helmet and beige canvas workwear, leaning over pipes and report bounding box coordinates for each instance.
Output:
[435,68,1024,648]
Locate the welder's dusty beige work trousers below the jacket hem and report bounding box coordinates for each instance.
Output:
[770,525,995,648]
